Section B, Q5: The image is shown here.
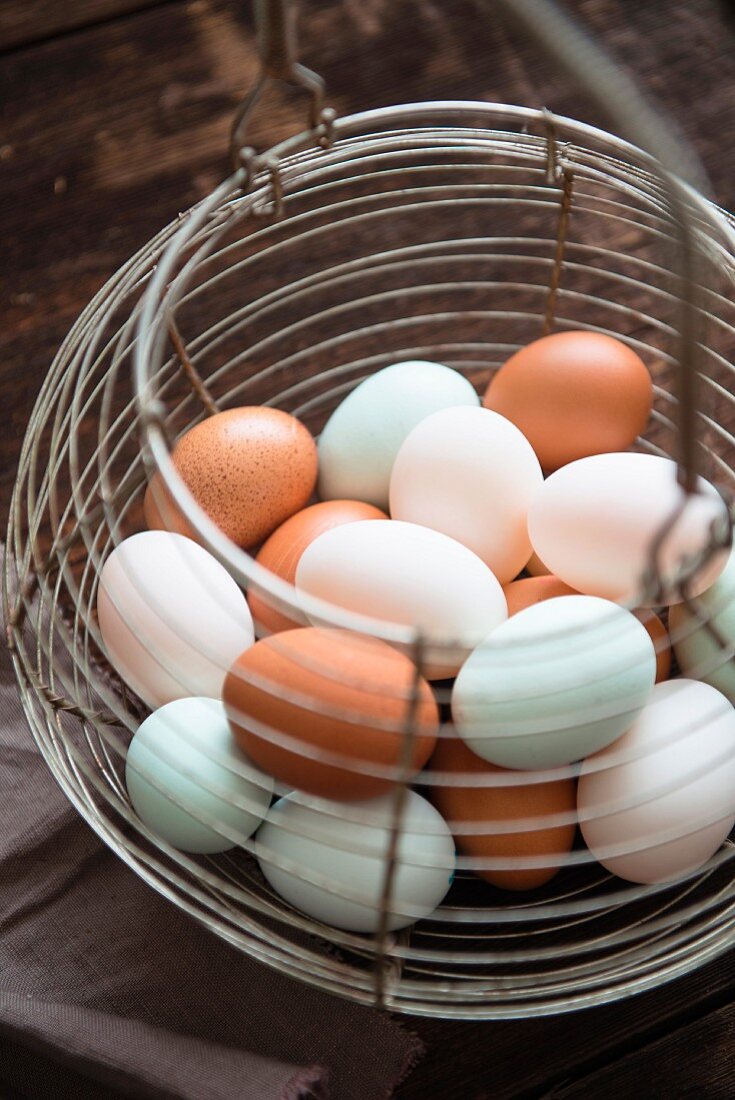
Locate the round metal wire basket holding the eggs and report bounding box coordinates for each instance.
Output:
[4,0,735,1018]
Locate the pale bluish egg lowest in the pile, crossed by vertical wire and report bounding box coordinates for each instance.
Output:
[256,790,454,933]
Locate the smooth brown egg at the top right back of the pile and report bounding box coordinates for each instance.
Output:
[483,332,654,471]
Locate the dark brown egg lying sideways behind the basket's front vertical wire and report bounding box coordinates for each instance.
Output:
[222,627,439,800]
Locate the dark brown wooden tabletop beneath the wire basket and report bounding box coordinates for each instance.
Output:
[0,0,735,1100]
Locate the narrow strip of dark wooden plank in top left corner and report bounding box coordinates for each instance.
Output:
[0,0,173,53]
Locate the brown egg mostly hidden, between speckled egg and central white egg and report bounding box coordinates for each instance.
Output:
[248,501,388,635]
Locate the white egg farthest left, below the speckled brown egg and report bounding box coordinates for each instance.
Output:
[97,531,254,708]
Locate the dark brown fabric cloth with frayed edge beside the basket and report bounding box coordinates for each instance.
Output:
[0,558,420,1100]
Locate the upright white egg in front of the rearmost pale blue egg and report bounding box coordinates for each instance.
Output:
[391,408,544,584]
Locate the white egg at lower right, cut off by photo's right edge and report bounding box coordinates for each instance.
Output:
[578,679,735,883]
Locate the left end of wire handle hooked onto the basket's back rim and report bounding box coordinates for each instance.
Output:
[230,0,336,173]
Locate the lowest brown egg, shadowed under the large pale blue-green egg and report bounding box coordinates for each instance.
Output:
[430,733,577,890]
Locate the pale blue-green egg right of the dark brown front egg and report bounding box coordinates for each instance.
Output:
[452,596,656,769]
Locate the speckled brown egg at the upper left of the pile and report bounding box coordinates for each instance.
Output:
[145,406,317,548]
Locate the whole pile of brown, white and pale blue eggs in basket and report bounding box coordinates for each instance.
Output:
[97,332,735,933]
